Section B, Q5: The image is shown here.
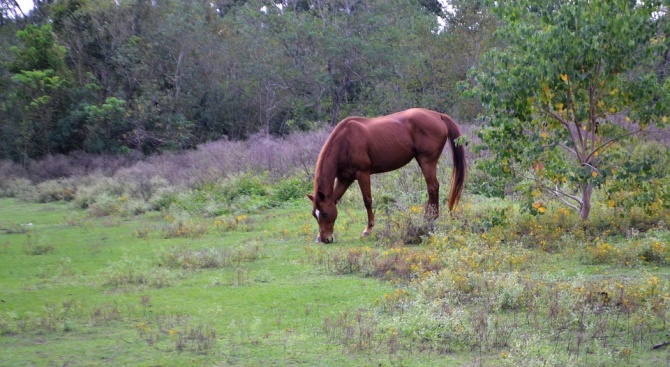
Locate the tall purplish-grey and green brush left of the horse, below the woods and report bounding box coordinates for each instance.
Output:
[0,130,328,216]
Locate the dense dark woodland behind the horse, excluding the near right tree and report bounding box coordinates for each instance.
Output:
[0,0,493,162]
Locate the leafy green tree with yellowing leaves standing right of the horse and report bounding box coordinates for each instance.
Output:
[471,0,670,220]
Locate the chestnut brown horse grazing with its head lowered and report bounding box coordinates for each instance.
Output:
[307,108,466,243]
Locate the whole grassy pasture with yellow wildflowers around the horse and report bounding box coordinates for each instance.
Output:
[0,132,670,366]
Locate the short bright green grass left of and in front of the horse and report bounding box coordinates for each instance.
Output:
[0,199,400,366]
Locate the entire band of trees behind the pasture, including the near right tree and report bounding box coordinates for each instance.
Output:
[0,0,670,219]
